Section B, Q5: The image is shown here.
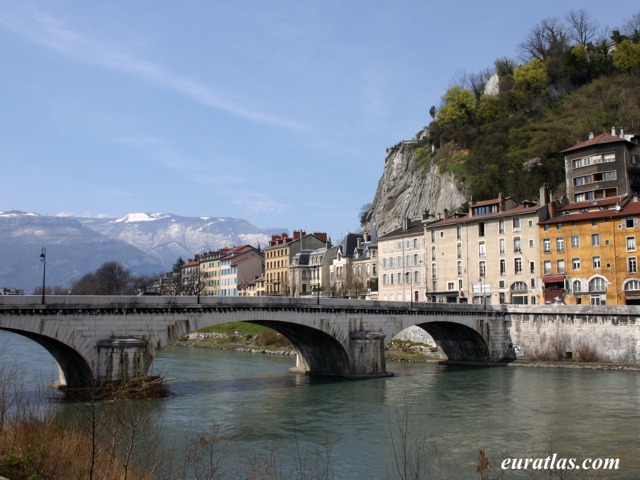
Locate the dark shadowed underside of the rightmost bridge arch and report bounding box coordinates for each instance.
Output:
[416,322,491,362]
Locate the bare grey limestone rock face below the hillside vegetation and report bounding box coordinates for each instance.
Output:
[362,141,467,235]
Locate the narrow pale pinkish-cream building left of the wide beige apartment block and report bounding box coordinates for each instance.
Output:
[378,219,427,302]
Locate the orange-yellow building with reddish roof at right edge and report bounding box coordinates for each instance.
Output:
[540,196,640,305]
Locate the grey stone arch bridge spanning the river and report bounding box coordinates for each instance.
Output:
[0,296,510,387]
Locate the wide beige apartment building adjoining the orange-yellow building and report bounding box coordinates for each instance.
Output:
[425,187,549,304]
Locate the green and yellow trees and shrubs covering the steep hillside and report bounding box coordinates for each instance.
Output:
[402,10,640,207]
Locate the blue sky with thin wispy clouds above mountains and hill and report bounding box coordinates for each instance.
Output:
[0,0,640,241]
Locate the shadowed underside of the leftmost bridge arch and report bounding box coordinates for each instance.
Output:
[0,328,93,388]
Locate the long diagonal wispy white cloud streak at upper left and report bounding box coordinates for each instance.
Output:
[0,8,310,132]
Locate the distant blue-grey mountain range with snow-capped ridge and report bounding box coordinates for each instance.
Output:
[0,210,286,294]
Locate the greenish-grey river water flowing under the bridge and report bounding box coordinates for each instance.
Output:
[0,333,640,479]
